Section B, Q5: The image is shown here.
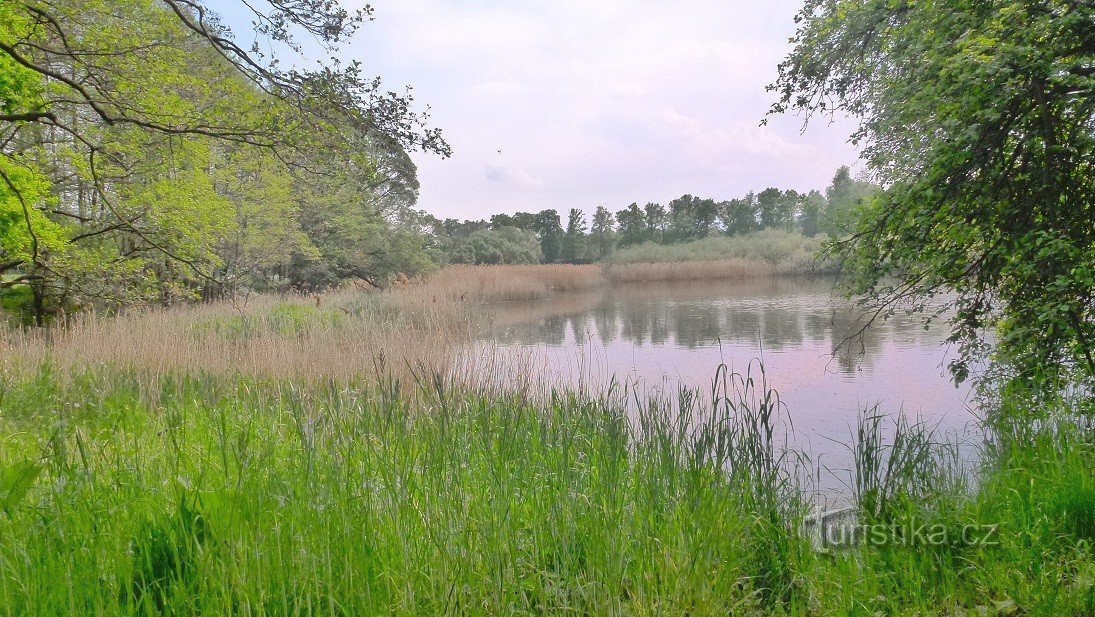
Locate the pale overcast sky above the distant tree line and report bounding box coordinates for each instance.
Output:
[258,0,857,218]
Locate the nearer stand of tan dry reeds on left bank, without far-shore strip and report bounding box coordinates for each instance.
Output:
[0,294,473,381]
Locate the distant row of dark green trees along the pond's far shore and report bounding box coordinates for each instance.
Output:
[424,167,878,264]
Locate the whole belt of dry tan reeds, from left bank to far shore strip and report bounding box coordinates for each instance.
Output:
[0,259,792,382]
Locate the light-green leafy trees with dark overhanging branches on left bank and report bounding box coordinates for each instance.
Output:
[0,0,448,323]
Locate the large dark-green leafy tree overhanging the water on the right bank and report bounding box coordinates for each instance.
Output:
[772,0,1095,385]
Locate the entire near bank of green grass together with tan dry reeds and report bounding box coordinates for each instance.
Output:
[0,268,1095,615]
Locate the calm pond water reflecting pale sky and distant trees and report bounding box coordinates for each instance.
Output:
[475,279,973,490]
